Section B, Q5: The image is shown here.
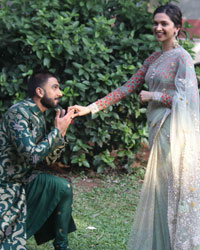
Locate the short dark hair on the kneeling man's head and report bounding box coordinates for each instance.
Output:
[28,72,56,97]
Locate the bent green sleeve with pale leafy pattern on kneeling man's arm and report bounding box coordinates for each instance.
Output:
[4,109,65,165]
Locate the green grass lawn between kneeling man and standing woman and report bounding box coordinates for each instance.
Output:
[27,175,141,250]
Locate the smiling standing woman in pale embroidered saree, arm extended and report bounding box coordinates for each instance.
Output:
[70,4,200,250]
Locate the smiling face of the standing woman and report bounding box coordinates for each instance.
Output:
[153,13,179,43]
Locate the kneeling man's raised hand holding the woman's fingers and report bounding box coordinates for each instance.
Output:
[55,109,77,137]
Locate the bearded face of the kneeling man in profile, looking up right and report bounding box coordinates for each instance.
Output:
[41,77,62,108]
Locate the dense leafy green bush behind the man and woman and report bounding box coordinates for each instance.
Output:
[0,0,197,172]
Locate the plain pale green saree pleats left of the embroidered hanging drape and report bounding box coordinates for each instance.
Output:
[127,117,170,250]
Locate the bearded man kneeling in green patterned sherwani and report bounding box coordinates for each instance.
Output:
[0,73,76,250]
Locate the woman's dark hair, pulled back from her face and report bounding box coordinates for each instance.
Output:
[153,3,182,31]
